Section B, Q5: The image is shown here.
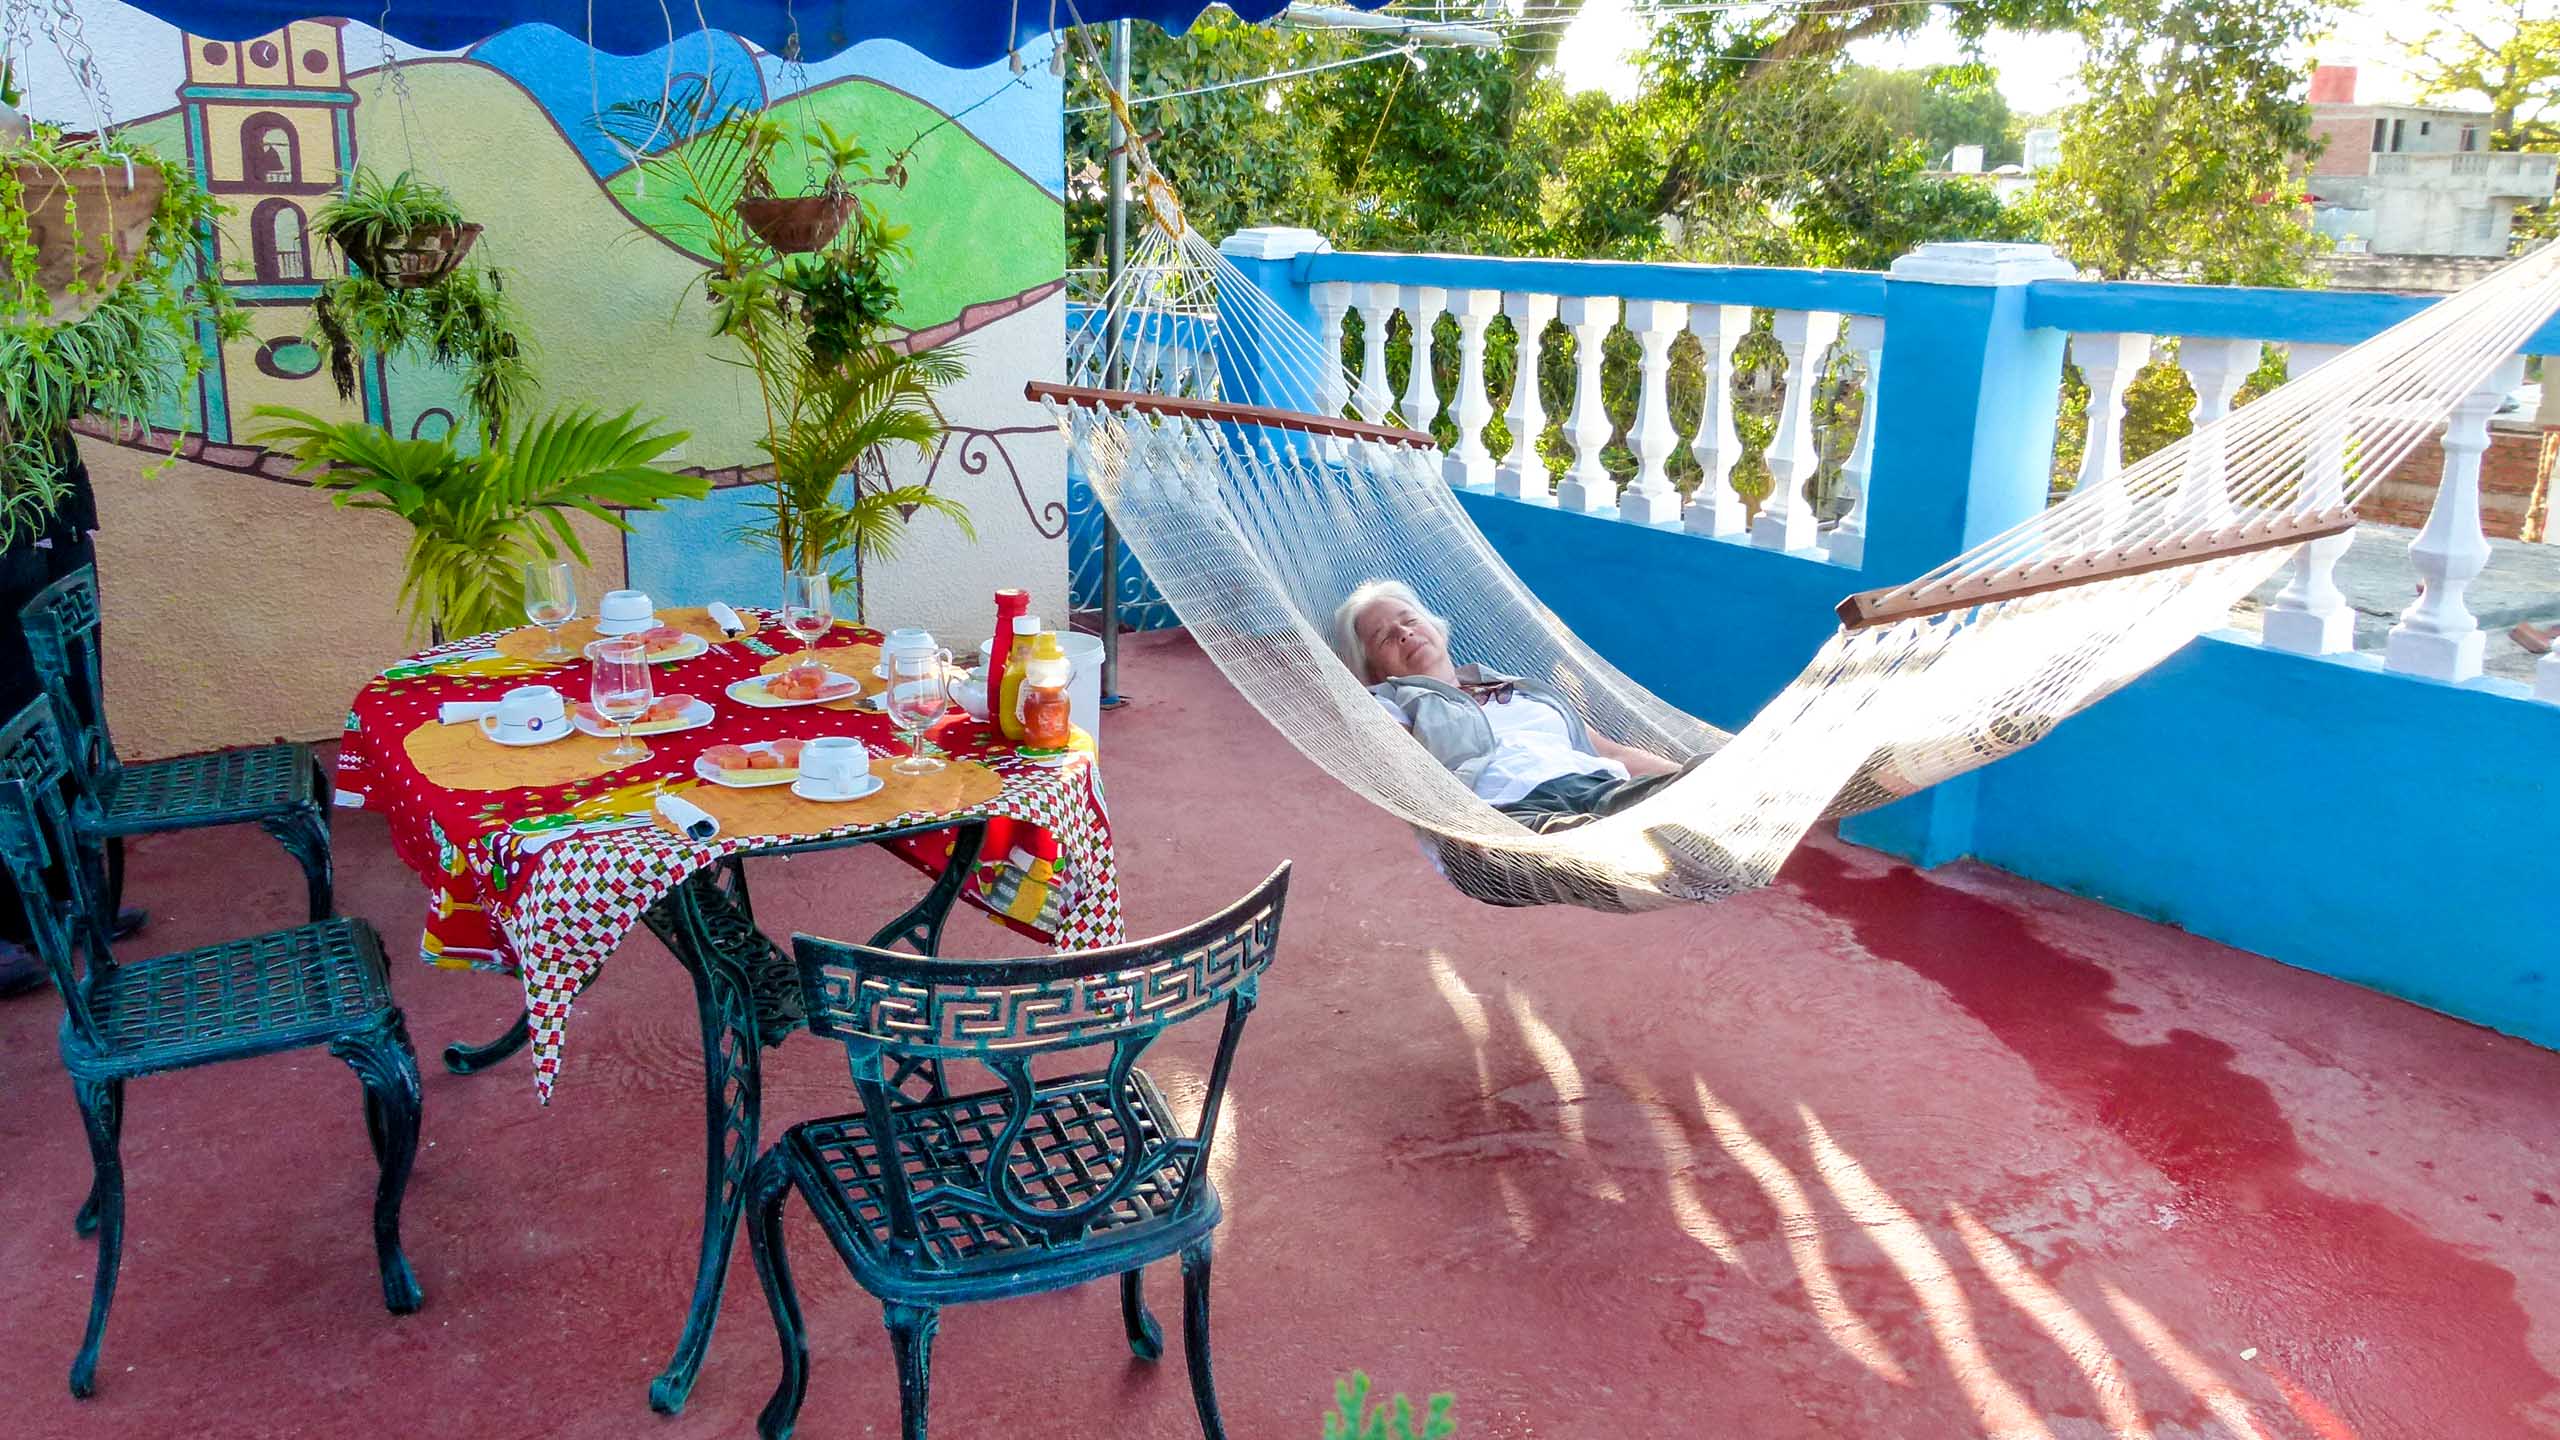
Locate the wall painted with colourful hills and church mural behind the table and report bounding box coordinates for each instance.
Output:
[28,0,1068,756]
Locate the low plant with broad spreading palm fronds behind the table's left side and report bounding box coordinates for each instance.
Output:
[253,405,709,635]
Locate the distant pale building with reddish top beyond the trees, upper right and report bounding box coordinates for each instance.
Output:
[2309,64,2560,256]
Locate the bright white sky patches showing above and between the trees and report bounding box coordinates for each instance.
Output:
[1556,0,2478,115]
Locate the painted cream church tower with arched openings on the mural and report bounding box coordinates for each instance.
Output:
[179,20,384,441]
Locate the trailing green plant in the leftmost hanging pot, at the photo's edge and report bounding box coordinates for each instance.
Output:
[0,126,248,543]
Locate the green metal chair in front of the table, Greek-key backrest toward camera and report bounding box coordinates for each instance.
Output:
[748,863,1288,1440]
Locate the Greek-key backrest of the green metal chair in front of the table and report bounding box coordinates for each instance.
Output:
[791,863,1288,1245]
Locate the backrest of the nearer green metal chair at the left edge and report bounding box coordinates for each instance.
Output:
[0,700,115,1045]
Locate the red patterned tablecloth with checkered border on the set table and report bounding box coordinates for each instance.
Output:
[338,612,1121,1102]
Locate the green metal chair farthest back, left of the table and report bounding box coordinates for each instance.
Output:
[18,566,333,920]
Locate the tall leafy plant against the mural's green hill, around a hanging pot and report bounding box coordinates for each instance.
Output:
[596,85,975,618]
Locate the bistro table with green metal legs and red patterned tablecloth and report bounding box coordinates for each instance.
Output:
[338,607,1121,1414]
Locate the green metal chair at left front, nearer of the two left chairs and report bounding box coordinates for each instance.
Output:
[0,700,422,1396]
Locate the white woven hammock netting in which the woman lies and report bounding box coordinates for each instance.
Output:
[1034,184,2560,910]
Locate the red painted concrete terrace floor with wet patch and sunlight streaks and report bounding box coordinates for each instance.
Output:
[0,635,2560,1440]
